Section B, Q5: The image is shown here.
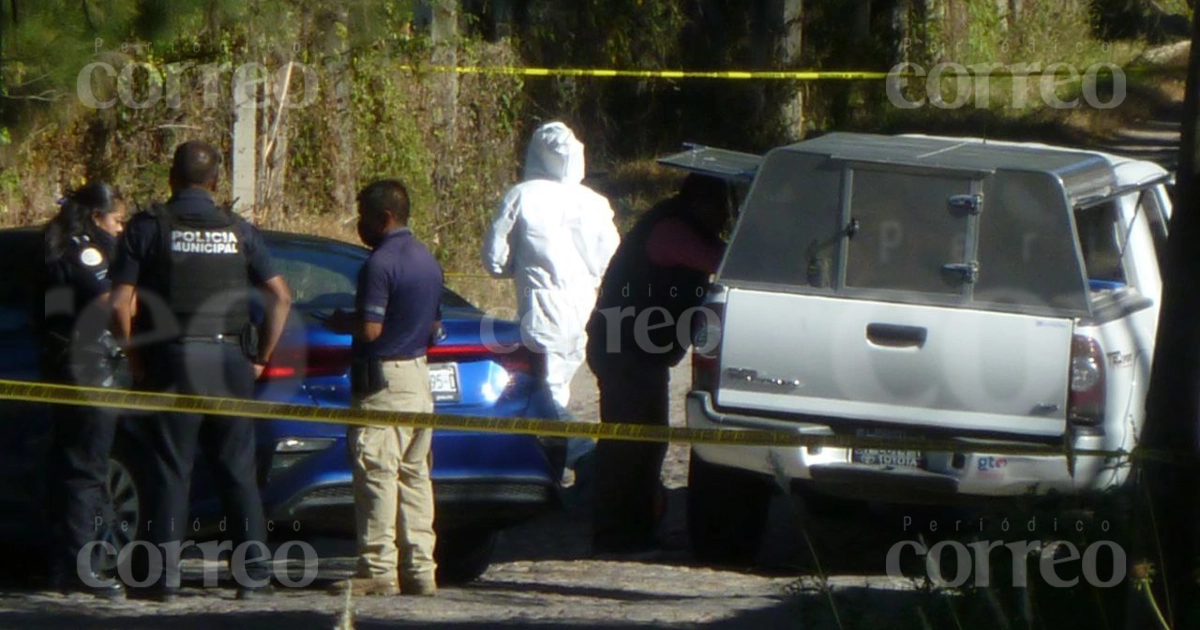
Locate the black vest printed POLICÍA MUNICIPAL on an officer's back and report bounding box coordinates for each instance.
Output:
[156,205,250,337]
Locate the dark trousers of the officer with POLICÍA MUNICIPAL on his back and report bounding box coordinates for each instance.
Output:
[139,342,270,587]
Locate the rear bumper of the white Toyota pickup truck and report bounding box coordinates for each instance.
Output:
[686,391,1129,503]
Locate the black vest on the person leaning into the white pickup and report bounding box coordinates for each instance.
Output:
[588,197,708,365]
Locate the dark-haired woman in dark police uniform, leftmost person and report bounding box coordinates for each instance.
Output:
[42,184,126,599]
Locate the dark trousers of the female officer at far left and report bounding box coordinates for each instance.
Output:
[47,404,119,576]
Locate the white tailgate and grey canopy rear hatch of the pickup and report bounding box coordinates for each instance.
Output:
[715,151,1086,438]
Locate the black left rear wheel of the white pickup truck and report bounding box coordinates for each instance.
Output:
[688,451,773,566]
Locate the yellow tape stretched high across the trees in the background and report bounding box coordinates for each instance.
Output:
[400,62,1187,80]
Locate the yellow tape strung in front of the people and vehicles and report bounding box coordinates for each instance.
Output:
[0,379,1194,463]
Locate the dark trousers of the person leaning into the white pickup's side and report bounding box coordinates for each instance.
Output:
[592,361,671,551]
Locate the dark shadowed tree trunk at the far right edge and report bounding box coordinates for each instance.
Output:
[1128,3,1200,629]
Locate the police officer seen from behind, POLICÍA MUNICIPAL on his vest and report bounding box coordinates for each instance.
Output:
[112,142,292,601]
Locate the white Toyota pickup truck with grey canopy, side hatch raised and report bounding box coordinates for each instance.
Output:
[661,133,1171,559]
